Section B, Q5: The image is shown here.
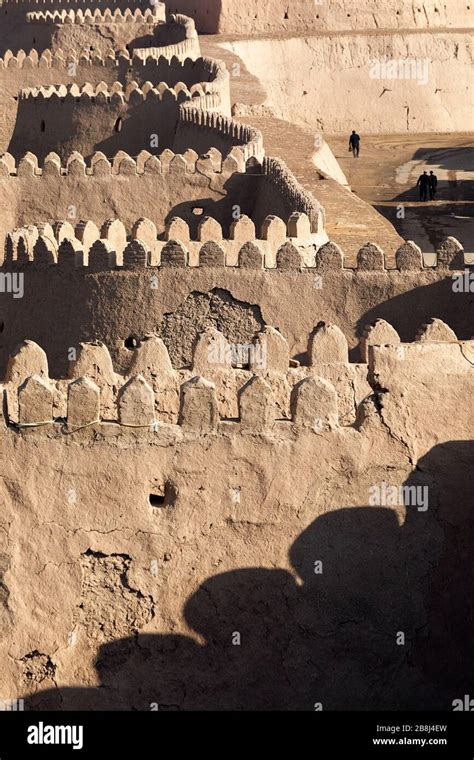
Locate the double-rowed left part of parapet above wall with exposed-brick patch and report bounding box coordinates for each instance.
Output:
[5,208,326,272]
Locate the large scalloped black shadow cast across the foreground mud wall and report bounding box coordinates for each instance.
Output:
[20,441,474,711]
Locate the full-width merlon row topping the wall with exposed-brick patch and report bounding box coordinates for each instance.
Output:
[4,217,469,274]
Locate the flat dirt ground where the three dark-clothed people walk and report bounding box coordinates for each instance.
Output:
[326,134,474,253]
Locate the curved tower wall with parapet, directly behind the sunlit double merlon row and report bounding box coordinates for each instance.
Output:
[0,147,327,256]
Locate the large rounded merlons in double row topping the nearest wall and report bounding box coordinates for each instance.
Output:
[1,320,468,435]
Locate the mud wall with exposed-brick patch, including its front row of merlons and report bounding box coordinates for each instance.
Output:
[0,230,472,373]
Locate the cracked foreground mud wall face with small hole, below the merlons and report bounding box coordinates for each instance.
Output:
[0,341,474,710]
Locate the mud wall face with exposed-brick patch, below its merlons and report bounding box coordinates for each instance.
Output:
[0,239,472,374]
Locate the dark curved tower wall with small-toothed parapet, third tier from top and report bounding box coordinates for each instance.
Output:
[8,54,232,160]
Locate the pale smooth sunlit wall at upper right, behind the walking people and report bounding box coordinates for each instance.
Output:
[224,27,473,133]
